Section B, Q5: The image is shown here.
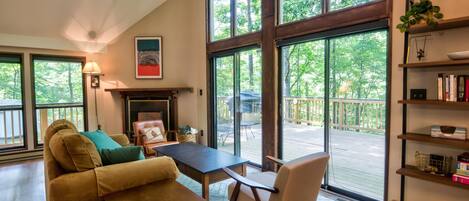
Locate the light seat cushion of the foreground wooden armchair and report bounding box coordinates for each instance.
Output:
[228,172,277,201]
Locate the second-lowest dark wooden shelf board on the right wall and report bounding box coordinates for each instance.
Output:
[397,133,469,150]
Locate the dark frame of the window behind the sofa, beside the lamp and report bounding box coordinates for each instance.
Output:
[30,54,88,149]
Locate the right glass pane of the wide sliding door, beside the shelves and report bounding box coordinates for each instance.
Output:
[329,31,387,200]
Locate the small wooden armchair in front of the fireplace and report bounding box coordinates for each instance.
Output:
[133,120,179,155]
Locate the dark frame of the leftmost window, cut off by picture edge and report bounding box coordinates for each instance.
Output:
[0,52,28,152]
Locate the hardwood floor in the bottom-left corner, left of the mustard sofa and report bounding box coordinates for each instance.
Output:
[0,159,45,201]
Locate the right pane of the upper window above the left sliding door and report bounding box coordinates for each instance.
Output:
[236,0,261,35]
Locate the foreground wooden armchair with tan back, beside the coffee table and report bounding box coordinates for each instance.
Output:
[223,152,329,201]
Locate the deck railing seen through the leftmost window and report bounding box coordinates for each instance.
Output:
[0,106,24,148]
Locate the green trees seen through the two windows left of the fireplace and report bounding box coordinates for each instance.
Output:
[0,60,83,105]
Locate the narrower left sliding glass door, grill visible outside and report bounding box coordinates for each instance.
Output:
[213,49,262,164]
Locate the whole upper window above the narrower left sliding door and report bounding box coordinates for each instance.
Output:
[209,0,261,41]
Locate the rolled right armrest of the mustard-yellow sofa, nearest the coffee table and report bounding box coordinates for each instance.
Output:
[95,157,179,197]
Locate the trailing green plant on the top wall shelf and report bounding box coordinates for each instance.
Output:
[396,0,443,32]
